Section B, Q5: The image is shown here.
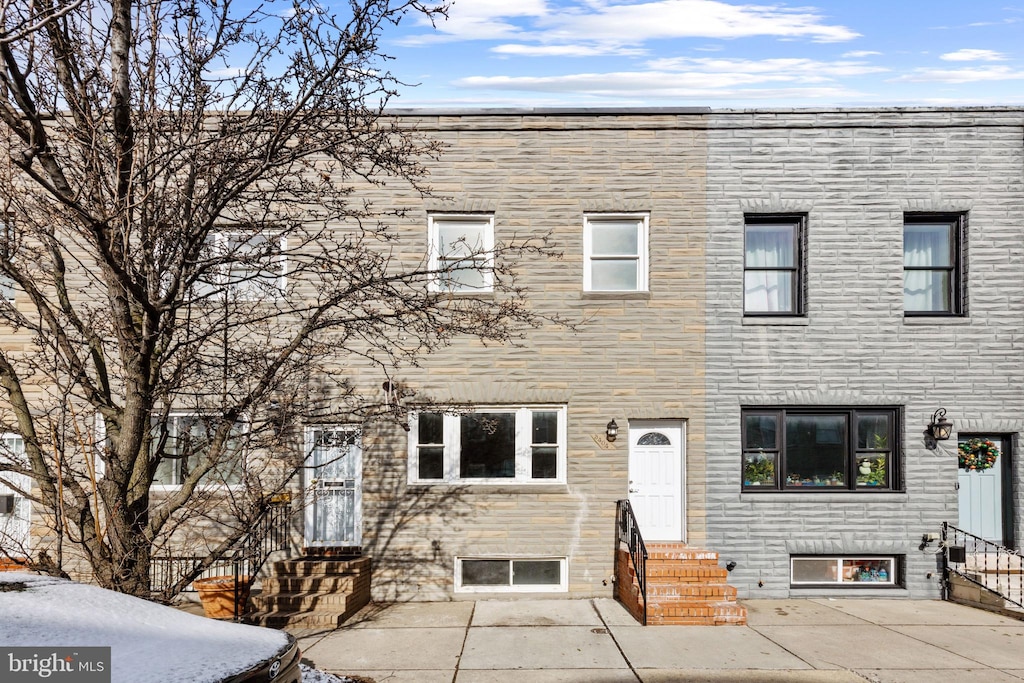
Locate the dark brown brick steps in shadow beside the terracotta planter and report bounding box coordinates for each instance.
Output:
[249,557,371,629]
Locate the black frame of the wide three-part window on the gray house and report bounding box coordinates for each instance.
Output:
[739,405,904,495]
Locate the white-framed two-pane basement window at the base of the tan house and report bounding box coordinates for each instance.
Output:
[455,557,568,593]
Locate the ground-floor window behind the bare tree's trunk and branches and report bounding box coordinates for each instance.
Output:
[152,415,244,486]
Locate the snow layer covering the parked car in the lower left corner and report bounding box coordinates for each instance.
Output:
[0,572,291,683]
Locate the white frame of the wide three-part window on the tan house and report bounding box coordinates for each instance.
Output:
[409,405,568,485]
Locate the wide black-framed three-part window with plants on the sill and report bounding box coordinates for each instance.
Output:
[741,408,900,493]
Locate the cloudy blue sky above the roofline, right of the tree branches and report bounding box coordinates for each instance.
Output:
[384,0,1024,109]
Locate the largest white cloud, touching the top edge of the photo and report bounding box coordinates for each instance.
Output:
[401,0,859,49]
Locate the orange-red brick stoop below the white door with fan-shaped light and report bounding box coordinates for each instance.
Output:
[615,543,746,626]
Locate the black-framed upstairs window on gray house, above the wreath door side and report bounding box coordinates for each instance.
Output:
[903,213,967,315]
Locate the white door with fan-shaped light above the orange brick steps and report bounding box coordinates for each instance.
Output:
[630,420,685,542]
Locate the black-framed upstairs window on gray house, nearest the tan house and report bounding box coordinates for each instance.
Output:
[743,215,806,315]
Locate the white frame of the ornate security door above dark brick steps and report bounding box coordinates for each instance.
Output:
[302,425,362,548]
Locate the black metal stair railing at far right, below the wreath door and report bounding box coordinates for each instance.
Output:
[942,522,1024,607]
